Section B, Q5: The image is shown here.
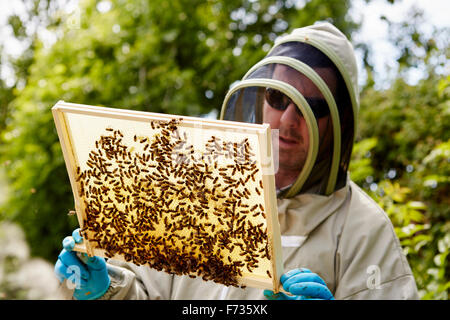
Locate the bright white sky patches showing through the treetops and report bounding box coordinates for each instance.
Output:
[0,0,450,85]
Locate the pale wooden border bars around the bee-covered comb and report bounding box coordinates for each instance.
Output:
[52,101,283,293]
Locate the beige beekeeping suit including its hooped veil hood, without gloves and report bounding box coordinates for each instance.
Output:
[98,23,418,299]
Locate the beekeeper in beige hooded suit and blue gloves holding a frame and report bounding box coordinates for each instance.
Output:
[55,23,418,300]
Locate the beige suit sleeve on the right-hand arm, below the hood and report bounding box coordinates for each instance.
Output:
[335,188,419,300]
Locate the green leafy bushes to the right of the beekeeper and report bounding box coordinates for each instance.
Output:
[350,59,450,299]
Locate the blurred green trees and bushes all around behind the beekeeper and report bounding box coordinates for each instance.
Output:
[0,0,450,299]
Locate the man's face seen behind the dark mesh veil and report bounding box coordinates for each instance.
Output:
[263,65,336,188]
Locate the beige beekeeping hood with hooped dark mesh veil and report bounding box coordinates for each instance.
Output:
[220,23,359,198]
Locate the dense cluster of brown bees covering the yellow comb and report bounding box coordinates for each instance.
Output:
[76,119,271,287]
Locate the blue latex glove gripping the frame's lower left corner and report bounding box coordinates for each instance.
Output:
[55,229,110,300]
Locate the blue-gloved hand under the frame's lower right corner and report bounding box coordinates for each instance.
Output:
[264,268,334,300]
